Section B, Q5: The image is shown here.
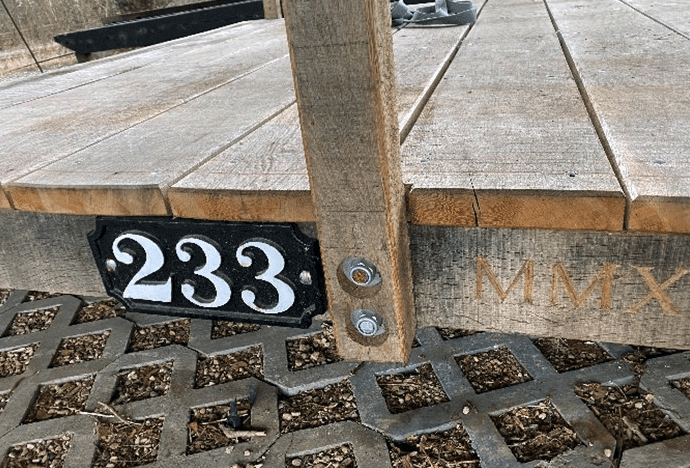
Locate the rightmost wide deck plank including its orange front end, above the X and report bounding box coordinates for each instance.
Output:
[548,0,690,233]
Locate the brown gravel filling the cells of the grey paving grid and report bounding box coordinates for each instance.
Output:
[0,290,690,468]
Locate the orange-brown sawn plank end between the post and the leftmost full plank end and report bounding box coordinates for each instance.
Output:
[167,188,316,223]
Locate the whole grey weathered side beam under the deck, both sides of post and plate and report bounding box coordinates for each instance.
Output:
[0,210,690,349]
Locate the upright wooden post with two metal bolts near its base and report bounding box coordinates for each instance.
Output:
[284,0,415,362]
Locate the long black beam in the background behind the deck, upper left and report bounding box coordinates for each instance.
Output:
[54,0,264,54]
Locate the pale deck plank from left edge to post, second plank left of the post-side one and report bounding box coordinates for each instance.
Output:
[0,22,289,209]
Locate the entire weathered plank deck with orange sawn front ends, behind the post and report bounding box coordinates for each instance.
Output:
[0,0,690,352]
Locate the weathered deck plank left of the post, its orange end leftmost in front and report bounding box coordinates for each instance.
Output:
[7,57,294,216]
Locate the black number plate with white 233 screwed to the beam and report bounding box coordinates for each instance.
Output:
[89,218,325,328]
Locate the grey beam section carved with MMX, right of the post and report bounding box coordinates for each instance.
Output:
[410,226,690,348]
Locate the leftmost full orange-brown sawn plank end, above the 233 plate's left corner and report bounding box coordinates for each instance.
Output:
[9,185,170,216]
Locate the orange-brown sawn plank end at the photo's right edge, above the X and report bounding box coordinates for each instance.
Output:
[628,197,690,234]
